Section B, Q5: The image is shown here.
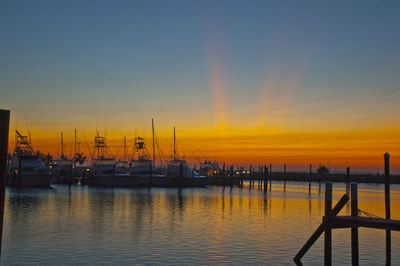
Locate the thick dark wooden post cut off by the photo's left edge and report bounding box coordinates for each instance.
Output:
[0,110,10,258]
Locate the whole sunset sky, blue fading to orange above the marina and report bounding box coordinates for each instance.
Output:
[0,0,400,172]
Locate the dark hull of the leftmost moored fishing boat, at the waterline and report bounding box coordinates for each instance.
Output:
[7,174,55,187]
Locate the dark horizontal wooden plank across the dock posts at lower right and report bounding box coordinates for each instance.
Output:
[323,216,400,231]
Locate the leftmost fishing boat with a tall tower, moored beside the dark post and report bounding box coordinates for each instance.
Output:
[7,130,55,187]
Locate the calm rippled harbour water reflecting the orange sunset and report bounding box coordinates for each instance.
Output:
[2,182,400,265]
